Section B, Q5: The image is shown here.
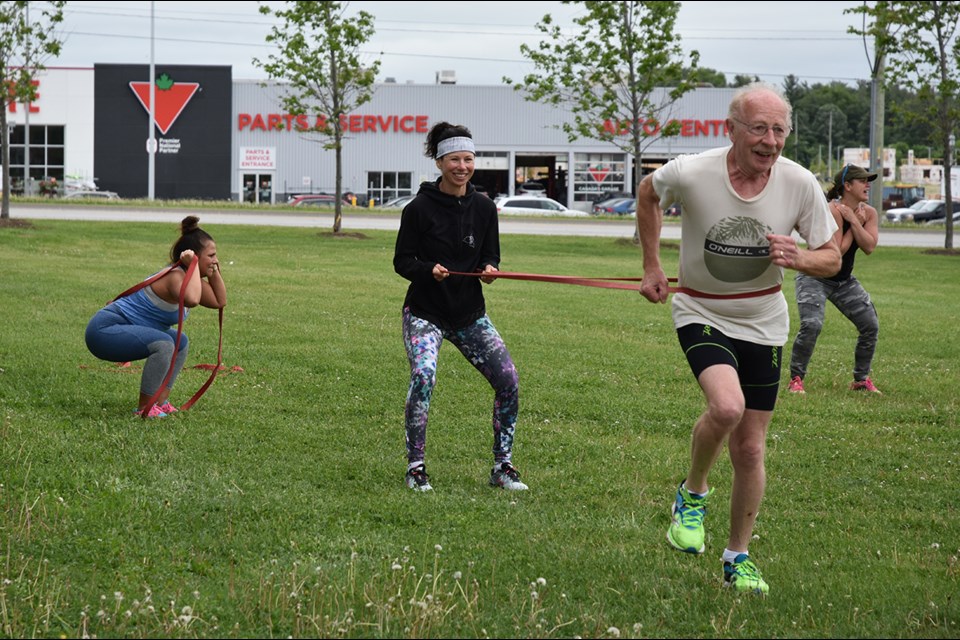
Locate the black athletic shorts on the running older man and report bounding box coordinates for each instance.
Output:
[677,324,783,411]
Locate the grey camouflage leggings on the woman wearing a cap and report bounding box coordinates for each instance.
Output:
[790,273,880,380]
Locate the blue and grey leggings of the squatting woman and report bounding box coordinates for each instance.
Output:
[84,305,190,396]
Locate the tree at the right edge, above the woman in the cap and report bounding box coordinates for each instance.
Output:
[844,1,960,249]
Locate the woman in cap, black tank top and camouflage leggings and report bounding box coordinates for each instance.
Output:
[788,164,880,393]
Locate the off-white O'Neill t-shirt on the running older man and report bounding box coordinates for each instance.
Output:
[653,147,837,346]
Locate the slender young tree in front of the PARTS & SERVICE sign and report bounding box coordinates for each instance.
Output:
[253,2,380,233]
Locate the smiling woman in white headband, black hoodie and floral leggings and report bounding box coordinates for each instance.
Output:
[393,122,527,491]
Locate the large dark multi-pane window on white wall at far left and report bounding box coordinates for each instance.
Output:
[4,125,64,194]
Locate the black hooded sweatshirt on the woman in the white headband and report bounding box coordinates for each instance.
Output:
[393,178,500,331]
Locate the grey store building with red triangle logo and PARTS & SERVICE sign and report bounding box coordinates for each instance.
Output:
[7,64,735,211]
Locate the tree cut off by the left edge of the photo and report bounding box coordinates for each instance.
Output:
[0,1,66,220]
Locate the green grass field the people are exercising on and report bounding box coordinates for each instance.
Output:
[0,219,960,638]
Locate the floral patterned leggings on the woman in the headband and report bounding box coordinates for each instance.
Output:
[403,307,520,463]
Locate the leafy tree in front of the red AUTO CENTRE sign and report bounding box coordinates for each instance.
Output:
[504,0,700,194]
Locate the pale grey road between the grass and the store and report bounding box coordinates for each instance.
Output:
[10,204,944,248]
